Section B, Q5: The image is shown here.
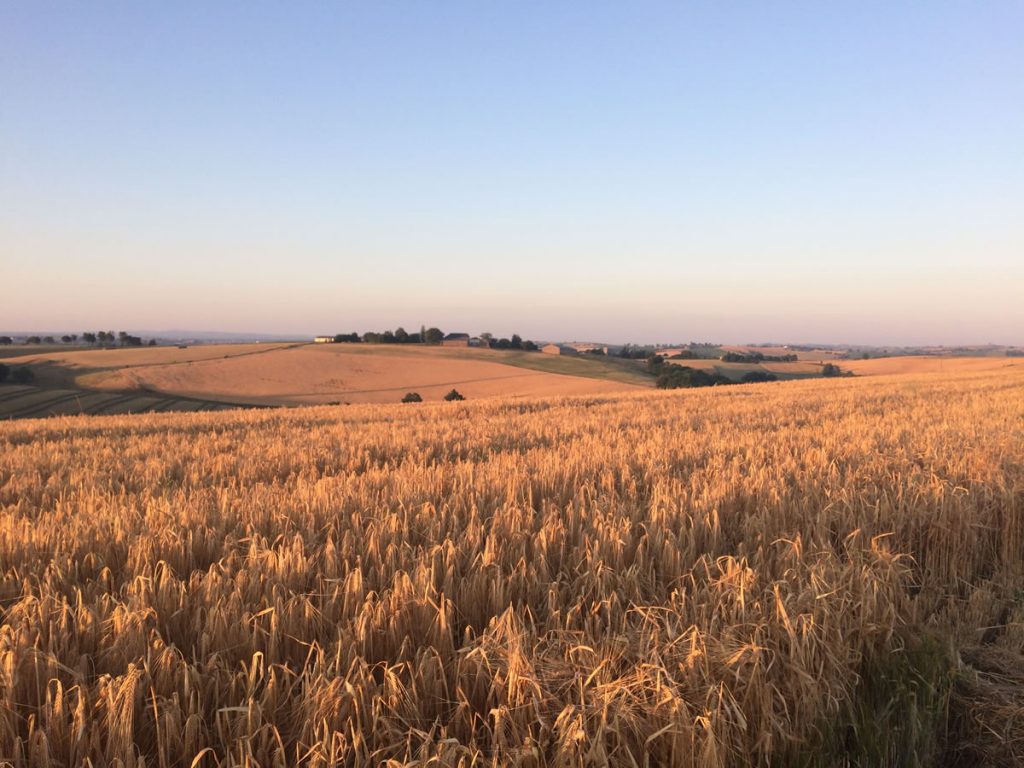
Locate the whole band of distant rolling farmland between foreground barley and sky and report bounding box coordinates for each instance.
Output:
[0,334,1024,418]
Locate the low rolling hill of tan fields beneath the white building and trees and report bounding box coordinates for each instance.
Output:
[0,343,652,415]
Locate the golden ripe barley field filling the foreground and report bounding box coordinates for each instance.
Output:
[0,366,1024,768]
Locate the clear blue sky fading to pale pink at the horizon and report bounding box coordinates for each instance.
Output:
[0,0,1024,344]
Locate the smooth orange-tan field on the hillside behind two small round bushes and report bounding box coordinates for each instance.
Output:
[81,344,636,404]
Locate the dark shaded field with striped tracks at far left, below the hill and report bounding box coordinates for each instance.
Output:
[0,386,247,419]
